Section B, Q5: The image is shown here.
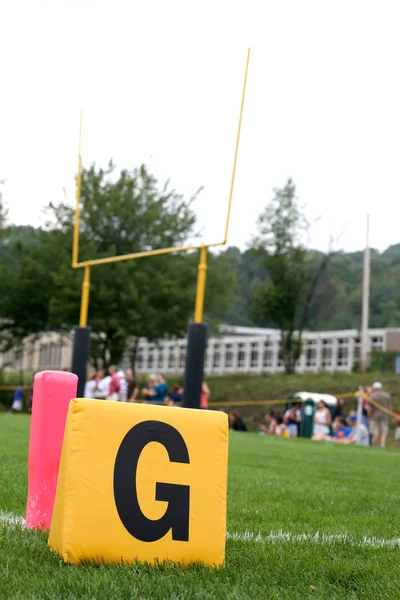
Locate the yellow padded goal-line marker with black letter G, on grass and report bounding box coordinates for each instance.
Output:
[49,399,228,566]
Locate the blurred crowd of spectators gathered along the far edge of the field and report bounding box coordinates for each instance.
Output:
[10,365,400,448]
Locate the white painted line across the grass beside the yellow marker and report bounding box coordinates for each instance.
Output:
[0,511,400,548]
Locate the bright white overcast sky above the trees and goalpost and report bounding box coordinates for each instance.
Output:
[0,0,400,250]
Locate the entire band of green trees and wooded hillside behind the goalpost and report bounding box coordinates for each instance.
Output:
[0,168,400,372]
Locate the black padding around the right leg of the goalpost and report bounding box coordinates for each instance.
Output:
[182,323,208,408]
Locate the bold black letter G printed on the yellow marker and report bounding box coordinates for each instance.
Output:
[114,421,190,542]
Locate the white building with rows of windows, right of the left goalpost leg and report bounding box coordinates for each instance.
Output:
[131,326,400,374]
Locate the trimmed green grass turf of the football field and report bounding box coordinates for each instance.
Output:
[0,414,400,600]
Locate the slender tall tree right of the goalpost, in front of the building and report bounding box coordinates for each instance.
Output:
[253,179,331,373]
